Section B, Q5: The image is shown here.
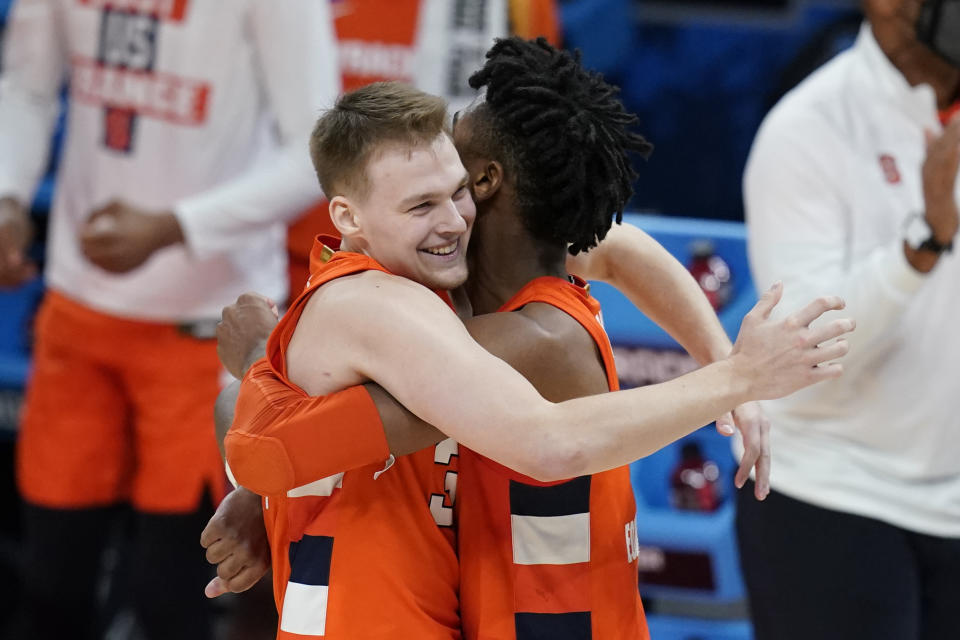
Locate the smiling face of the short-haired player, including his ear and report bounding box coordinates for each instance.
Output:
[331,134,476,289]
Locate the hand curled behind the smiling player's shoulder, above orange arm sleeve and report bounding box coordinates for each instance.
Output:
[217,293,280,380]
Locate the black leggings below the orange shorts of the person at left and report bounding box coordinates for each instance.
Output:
[13,500,213,640]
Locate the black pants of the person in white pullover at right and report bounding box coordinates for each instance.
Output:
[737,484,960,640]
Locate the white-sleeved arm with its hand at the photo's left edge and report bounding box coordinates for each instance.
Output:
[0,0,66,286]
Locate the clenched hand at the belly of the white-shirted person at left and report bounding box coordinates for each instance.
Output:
[80,200,183,273]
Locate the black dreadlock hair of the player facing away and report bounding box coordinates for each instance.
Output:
[470,37,653,255]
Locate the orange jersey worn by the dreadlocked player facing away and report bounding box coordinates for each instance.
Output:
[457,277,649,640]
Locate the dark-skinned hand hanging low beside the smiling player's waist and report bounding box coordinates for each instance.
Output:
[200,487,270,598]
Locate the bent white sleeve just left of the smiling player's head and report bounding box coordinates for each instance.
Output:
[174,0,340,256]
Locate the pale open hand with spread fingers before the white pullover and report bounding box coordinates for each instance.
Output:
[729,282,856,400]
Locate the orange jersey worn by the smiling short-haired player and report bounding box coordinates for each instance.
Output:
[242,241,460,640]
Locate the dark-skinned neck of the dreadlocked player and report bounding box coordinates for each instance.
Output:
[466,197,567,314]
